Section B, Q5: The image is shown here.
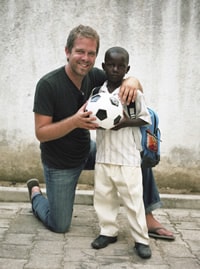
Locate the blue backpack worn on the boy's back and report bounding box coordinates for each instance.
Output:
[140,108,161,168]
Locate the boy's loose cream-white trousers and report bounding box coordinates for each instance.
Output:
[94,163,149,245]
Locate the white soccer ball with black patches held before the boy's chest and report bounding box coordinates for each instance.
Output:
[86,92,123,129]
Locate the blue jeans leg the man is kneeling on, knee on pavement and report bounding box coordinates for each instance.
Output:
[32,161,84,233]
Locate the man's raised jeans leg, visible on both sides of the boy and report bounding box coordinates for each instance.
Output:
[84,141,162,213]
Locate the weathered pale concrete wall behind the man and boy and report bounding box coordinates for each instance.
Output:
[0,0,200,189]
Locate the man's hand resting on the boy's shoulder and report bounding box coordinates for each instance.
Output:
[119,77,143,105]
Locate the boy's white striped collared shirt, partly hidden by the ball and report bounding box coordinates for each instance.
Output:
[96,82,151,166]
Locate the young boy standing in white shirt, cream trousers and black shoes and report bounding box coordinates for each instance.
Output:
[91,47,151,259]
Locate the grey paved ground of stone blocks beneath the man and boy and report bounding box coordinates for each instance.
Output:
[0,202,200,269]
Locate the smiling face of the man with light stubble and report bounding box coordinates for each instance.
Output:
[65,37,97,77]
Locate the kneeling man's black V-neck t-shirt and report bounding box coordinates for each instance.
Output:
[33,66,106,169]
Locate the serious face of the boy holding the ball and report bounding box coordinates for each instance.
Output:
[102,52,130,83]
